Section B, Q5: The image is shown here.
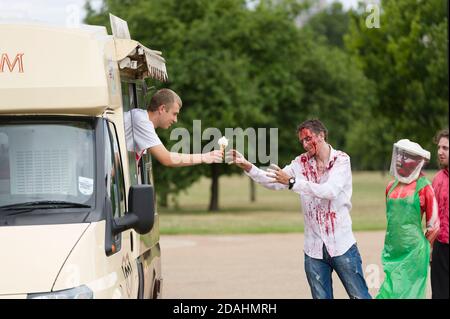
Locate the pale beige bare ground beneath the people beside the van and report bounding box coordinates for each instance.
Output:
[160,231,431,299]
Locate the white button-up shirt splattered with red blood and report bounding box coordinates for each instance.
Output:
[245,145,356,259]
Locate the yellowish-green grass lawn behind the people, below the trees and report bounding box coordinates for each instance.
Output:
[156,171,435,234]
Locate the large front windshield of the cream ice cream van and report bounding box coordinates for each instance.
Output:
[0,120,95,209]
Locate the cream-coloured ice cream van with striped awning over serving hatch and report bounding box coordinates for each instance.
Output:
[0,16,167,299]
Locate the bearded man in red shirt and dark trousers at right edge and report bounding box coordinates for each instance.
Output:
[431,129,449,299]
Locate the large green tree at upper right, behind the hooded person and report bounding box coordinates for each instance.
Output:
[346,0,448,169]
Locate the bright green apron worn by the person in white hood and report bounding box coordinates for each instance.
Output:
[376,177,430,299]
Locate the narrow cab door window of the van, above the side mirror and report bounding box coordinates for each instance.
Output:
[105,121,126,218]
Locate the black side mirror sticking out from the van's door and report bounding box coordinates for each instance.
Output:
[113,185,155,234]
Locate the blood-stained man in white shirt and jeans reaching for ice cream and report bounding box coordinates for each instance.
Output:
[228,120,371,299]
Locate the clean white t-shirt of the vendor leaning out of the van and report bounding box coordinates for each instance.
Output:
[123,109,162,154]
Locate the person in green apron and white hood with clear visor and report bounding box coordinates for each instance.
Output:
[376,139,439,299]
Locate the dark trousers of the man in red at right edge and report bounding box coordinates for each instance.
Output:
[431,240,449,299]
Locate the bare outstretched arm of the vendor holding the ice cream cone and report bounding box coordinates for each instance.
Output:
[148,144,223,167]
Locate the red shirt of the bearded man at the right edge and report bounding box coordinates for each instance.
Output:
[433,169,448,244]
